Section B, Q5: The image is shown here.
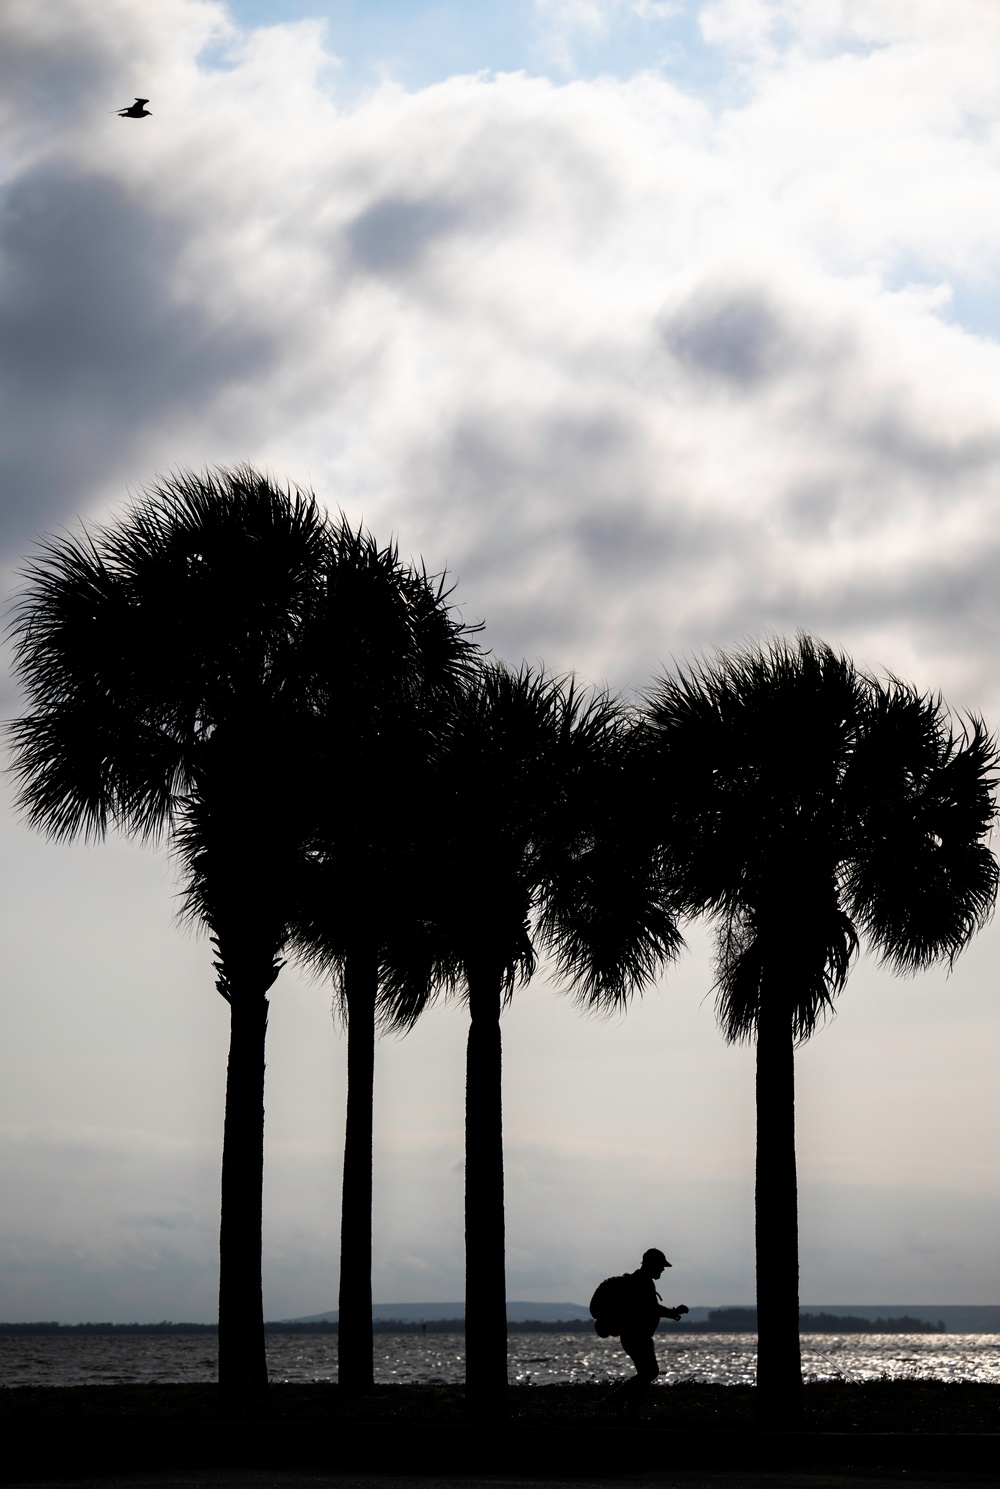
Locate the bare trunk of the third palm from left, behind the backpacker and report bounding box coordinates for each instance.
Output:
[466,966,507,1422]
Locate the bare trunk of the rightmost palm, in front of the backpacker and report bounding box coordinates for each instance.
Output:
[756,996,802,1425]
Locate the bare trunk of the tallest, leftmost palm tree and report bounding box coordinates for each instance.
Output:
[219,989,268,1418]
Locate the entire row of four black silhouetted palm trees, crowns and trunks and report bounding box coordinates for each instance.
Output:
[12,466,997,1421]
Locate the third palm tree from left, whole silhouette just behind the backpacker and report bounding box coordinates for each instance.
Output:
[385,664,679,1419]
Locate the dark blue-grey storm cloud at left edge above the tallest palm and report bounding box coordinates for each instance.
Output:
[0,167,274,546]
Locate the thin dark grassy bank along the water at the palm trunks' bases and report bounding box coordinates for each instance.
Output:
[0,1380,1000,1432]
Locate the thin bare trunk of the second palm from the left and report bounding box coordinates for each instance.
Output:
[336,948,378,1395]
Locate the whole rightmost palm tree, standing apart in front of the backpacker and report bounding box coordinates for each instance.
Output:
[644,636,997,1421]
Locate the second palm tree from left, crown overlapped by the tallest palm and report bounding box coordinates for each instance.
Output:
[290,550,478,1394]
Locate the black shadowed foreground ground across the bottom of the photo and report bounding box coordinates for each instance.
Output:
[0,1380,1000,1489]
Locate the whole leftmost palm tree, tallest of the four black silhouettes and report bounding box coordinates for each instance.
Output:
[13,468,332,1415]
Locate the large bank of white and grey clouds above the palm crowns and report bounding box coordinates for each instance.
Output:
[0,0,1000,723]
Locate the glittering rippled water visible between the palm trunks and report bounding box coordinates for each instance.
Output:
[0,1334,1000,1386]
